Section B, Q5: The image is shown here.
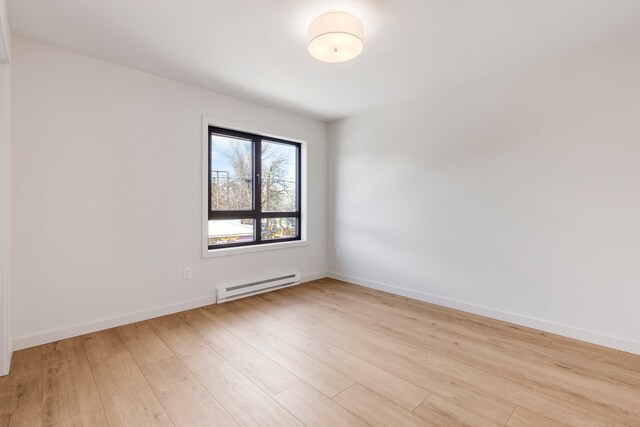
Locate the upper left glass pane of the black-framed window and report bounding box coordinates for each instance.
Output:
[209,134,253,211]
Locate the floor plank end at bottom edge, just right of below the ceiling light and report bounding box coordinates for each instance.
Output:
[333,383,432,427]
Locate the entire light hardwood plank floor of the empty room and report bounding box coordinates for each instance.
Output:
[0,279,640,427]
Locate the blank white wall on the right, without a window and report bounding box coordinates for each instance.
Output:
[328,33,640,353]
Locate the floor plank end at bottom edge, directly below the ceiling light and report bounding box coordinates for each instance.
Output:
[273,381,367,427]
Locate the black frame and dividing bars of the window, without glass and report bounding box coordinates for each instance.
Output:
[207,125,302,250]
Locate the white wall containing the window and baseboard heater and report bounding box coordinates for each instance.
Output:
[12,38,327,348]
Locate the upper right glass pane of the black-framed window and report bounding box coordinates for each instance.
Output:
[262,141,298,212]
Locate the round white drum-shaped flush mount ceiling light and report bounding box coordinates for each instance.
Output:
[307,12,364,62]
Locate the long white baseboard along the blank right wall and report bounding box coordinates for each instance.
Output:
[328,272,640,354]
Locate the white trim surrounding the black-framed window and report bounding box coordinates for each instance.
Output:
[200,116,309,258]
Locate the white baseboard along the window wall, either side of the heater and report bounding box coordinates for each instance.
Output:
[13,271,328,350]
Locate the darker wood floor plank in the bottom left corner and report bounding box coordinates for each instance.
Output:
[0,346,43,426]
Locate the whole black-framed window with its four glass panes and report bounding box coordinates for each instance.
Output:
[208,126,301,250]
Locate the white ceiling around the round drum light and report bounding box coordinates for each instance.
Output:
[8,0,640,120]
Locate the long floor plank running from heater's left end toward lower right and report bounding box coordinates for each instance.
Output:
[226,302,430,410]
